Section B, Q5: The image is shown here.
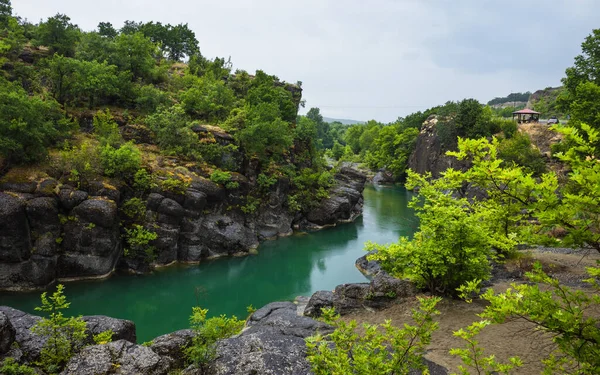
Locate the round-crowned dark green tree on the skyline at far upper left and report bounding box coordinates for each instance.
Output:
[36,13,81,57]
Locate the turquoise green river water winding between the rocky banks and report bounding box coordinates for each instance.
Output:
[0,186,416,342]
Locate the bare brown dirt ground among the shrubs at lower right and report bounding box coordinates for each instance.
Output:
[343,250,600,375]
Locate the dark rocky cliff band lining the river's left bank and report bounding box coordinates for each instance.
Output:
[0,168,366,291]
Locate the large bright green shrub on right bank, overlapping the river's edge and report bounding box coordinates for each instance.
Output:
[367,171,494,295]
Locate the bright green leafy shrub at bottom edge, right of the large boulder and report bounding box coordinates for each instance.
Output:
[306,297,440,375]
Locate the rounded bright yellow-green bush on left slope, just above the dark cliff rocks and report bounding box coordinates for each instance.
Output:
[100,142,142,178]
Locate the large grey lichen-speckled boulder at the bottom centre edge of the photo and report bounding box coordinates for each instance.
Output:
[214,302,332,375]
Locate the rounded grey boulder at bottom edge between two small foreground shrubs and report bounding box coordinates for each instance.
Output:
[61,340,170,375]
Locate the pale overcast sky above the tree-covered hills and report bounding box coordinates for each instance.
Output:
[12,0,600,122]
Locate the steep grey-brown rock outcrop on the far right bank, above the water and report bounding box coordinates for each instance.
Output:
[408,115,468,178]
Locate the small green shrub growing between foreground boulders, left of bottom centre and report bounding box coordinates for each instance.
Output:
[184,307,245,371]
